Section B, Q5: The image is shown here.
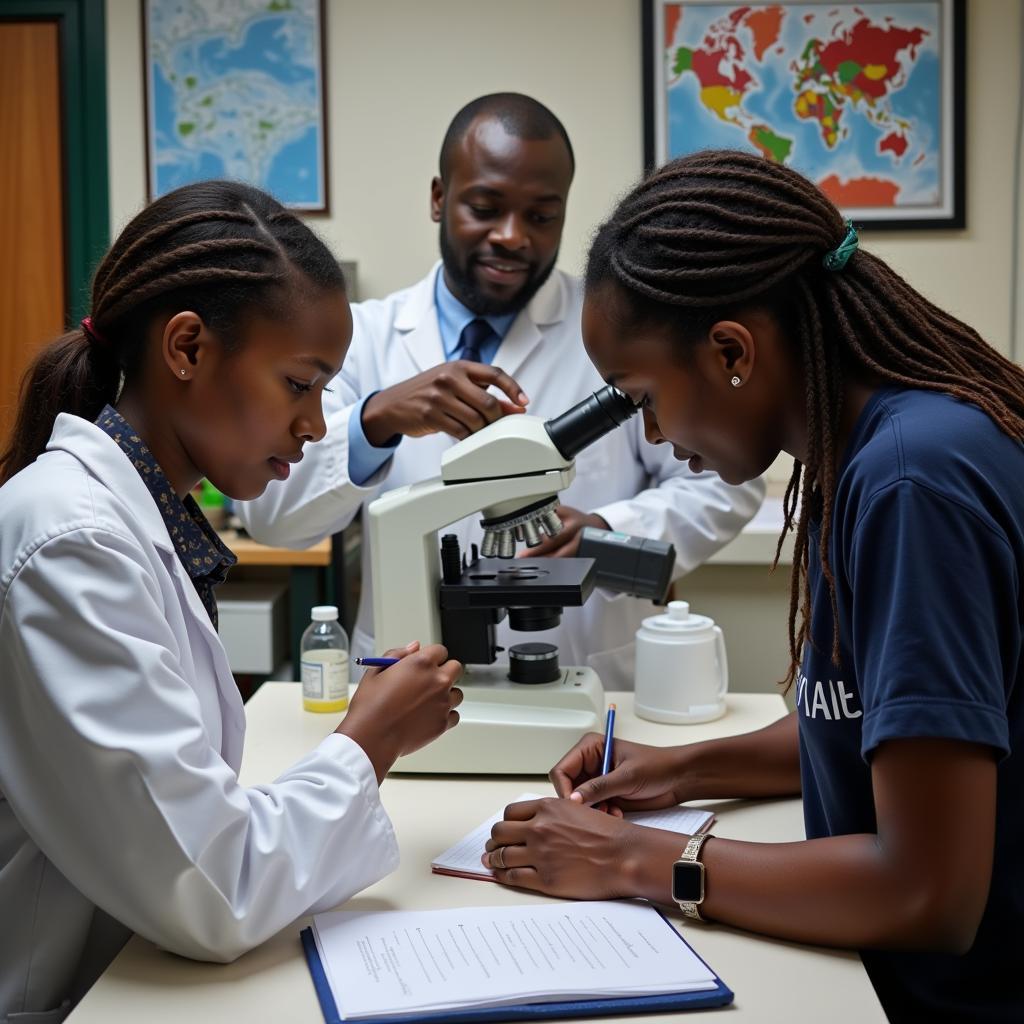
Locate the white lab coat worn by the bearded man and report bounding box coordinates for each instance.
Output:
[240,263,764,689]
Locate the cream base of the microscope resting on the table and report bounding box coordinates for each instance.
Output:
[392,665,605,775]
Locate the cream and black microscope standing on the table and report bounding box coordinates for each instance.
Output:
[368,386,675,774]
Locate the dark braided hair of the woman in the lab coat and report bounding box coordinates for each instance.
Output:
[0,181,345,483]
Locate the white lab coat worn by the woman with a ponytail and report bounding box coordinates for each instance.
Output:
[0,415,398,1024]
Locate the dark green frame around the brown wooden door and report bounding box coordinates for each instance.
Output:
[0,0,111,323]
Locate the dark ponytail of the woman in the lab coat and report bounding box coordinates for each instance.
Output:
[0,328,121,484]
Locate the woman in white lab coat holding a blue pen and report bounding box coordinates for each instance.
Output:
[0,182,461,1022]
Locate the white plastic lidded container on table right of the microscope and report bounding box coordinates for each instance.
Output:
[635,601,729,725]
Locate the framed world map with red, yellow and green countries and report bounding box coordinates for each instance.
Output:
[643,0,965,228]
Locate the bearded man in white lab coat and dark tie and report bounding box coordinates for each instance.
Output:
[241,93,764,689]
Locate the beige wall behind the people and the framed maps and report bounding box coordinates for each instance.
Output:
[106,0,1021,351]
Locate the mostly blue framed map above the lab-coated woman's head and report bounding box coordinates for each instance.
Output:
[141,0,328,212]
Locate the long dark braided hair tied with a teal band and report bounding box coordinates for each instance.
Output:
[587,150,1024,688]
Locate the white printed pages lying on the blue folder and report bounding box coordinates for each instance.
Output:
[313,901,717,1020]
